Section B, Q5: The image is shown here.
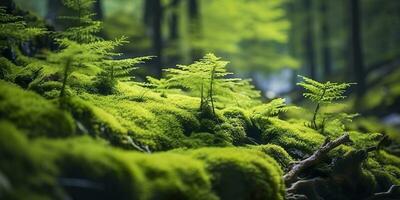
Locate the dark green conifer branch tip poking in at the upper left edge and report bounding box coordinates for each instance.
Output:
[0,7,46,48]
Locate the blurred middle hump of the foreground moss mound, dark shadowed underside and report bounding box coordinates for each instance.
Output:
[38,137,147,199]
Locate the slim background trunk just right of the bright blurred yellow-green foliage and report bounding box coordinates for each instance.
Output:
[304,0,316,79]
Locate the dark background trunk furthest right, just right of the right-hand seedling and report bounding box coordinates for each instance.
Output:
[350,0,366,97]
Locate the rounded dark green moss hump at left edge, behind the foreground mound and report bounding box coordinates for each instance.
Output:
[0,81,75,137]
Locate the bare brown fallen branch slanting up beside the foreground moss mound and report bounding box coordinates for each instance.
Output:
[283,133,351,186]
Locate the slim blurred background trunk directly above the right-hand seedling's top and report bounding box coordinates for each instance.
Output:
[320,0,332,80]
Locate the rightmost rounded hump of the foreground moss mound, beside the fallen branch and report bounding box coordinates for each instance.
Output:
[190,148,284,200]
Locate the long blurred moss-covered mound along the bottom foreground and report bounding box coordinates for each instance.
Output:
[0,122,284,200]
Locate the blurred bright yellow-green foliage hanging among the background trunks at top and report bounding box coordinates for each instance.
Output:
[192,0,299,73]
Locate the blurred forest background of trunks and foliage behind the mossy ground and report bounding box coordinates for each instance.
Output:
[5,0,400,119]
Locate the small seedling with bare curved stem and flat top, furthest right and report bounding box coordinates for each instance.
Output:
[297,75,354,130]
